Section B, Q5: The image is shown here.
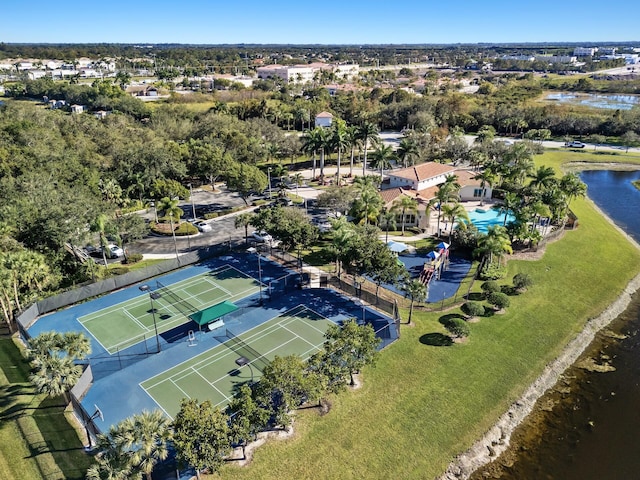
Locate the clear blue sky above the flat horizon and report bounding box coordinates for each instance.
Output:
[5,0,640,44]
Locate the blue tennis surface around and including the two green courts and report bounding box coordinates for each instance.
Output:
[29,254,397,431]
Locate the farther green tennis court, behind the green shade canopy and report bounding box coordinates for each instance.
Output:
[78,266,260,354]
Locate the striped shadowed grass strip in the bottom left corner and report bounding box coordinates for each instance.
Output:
[0,337,91,480]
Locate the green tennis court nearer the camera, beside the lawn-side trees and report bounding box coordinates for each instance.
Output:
[140,305,333,418]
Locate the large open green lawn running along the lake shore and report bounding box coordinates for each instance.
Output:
[216,148,640,480]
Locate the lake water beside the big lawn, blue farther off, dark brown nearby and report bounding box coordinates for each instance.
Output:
[472,170,640,480]
